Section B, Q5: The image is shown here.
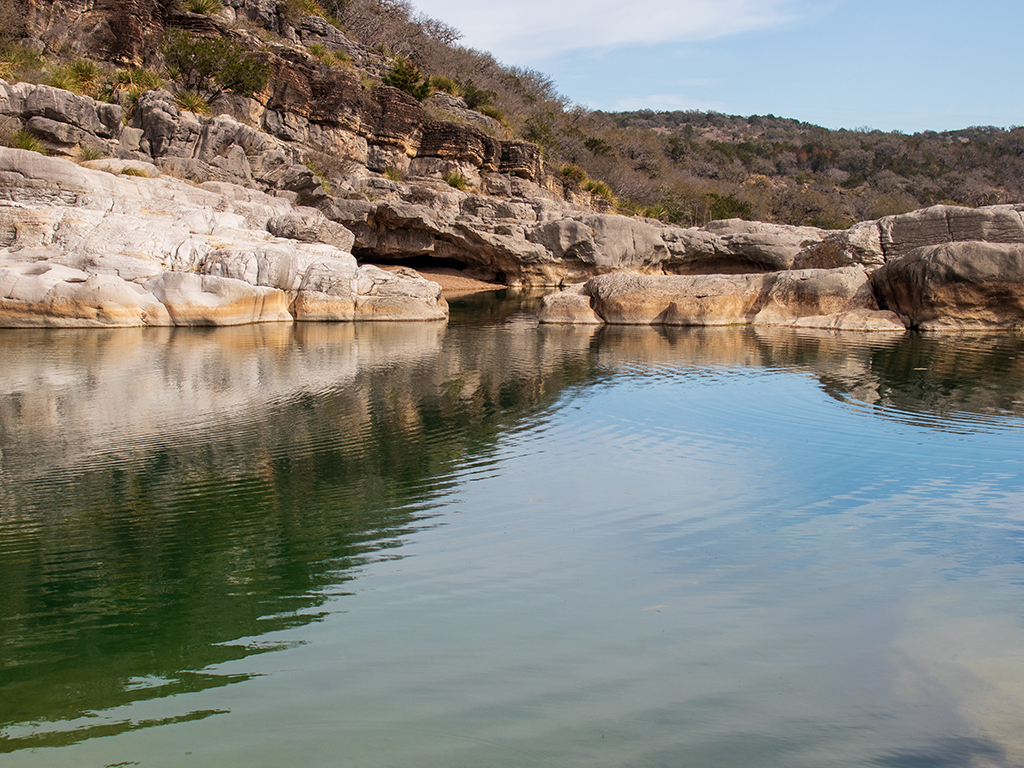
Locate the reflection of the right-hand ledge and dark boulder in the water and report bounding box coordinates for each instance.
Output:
[598,327,1024,429]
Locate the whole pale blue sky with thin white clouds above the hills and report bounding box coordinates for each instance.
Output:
[413,0,1024,133]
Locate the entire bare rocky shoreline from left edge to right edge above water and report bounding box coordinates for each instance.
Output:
[0,74,1024,332]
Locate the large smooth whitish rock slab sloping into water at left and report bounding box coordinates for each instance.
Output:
[0,148,447,327]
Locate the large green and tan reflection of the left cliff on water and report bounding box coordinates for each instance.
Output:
[0,324,592,752]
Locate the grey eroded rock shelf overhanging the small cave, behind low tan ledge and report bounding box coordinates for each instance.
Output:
[336,190,825,286]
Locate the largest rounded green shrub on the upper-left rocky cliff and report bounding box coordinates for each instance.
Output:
[163,31,270,100]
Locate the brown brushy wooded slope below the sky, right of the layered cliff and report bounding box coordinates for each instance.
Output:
[286,0,1024,228]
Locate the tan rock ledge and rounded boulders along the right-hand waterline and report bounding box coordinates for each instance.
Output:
[541,205,1024,331]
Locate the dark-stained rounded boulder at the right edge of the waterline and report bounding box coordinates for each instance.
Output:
[871,241,1024,331]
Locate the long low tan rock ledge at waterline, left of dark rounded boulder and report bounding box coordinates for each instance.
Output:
[541,267,905,331]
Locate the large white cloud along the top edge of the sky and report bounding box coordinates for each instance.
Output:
[414,0,797,63]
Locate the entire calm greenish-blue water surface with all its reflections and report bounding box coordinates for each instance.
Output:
[0,295,1024,768]
